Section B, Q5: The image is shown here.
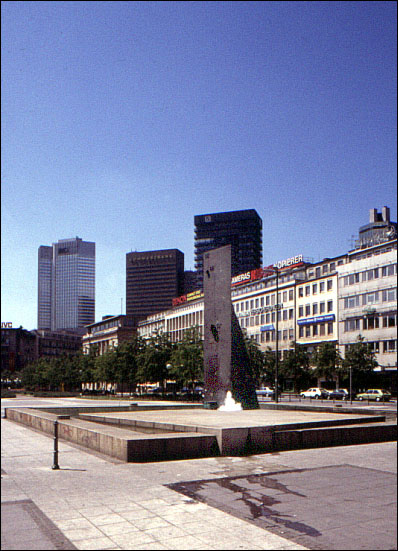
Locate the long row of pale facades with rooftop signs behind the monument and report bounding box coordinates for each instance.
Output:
[138,241,397,371]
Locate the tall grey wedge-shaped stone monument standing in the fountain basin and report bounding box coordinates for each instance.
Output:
[203,245,258,409]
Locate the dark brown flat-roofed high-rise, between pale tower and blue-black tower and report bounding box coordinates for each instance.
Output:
[126,249,184,319]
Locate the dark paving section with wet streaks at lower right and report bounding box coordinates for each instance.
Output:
[168,464,397,550]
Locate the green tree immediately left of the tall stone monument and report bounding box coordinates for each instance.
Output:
[168,326,203,392]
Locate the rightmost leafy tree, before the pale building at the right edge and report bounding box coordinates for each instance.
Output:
[340,335,378,389]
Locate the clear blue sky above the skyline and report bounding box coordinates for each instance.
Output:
[1,1,397,329]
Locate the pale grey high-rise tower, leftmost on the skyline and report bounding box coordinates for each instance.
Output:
[37,237,95,331]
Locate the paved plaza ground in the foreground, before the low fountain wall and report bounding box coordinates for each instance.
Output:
[1,419,397,550]
